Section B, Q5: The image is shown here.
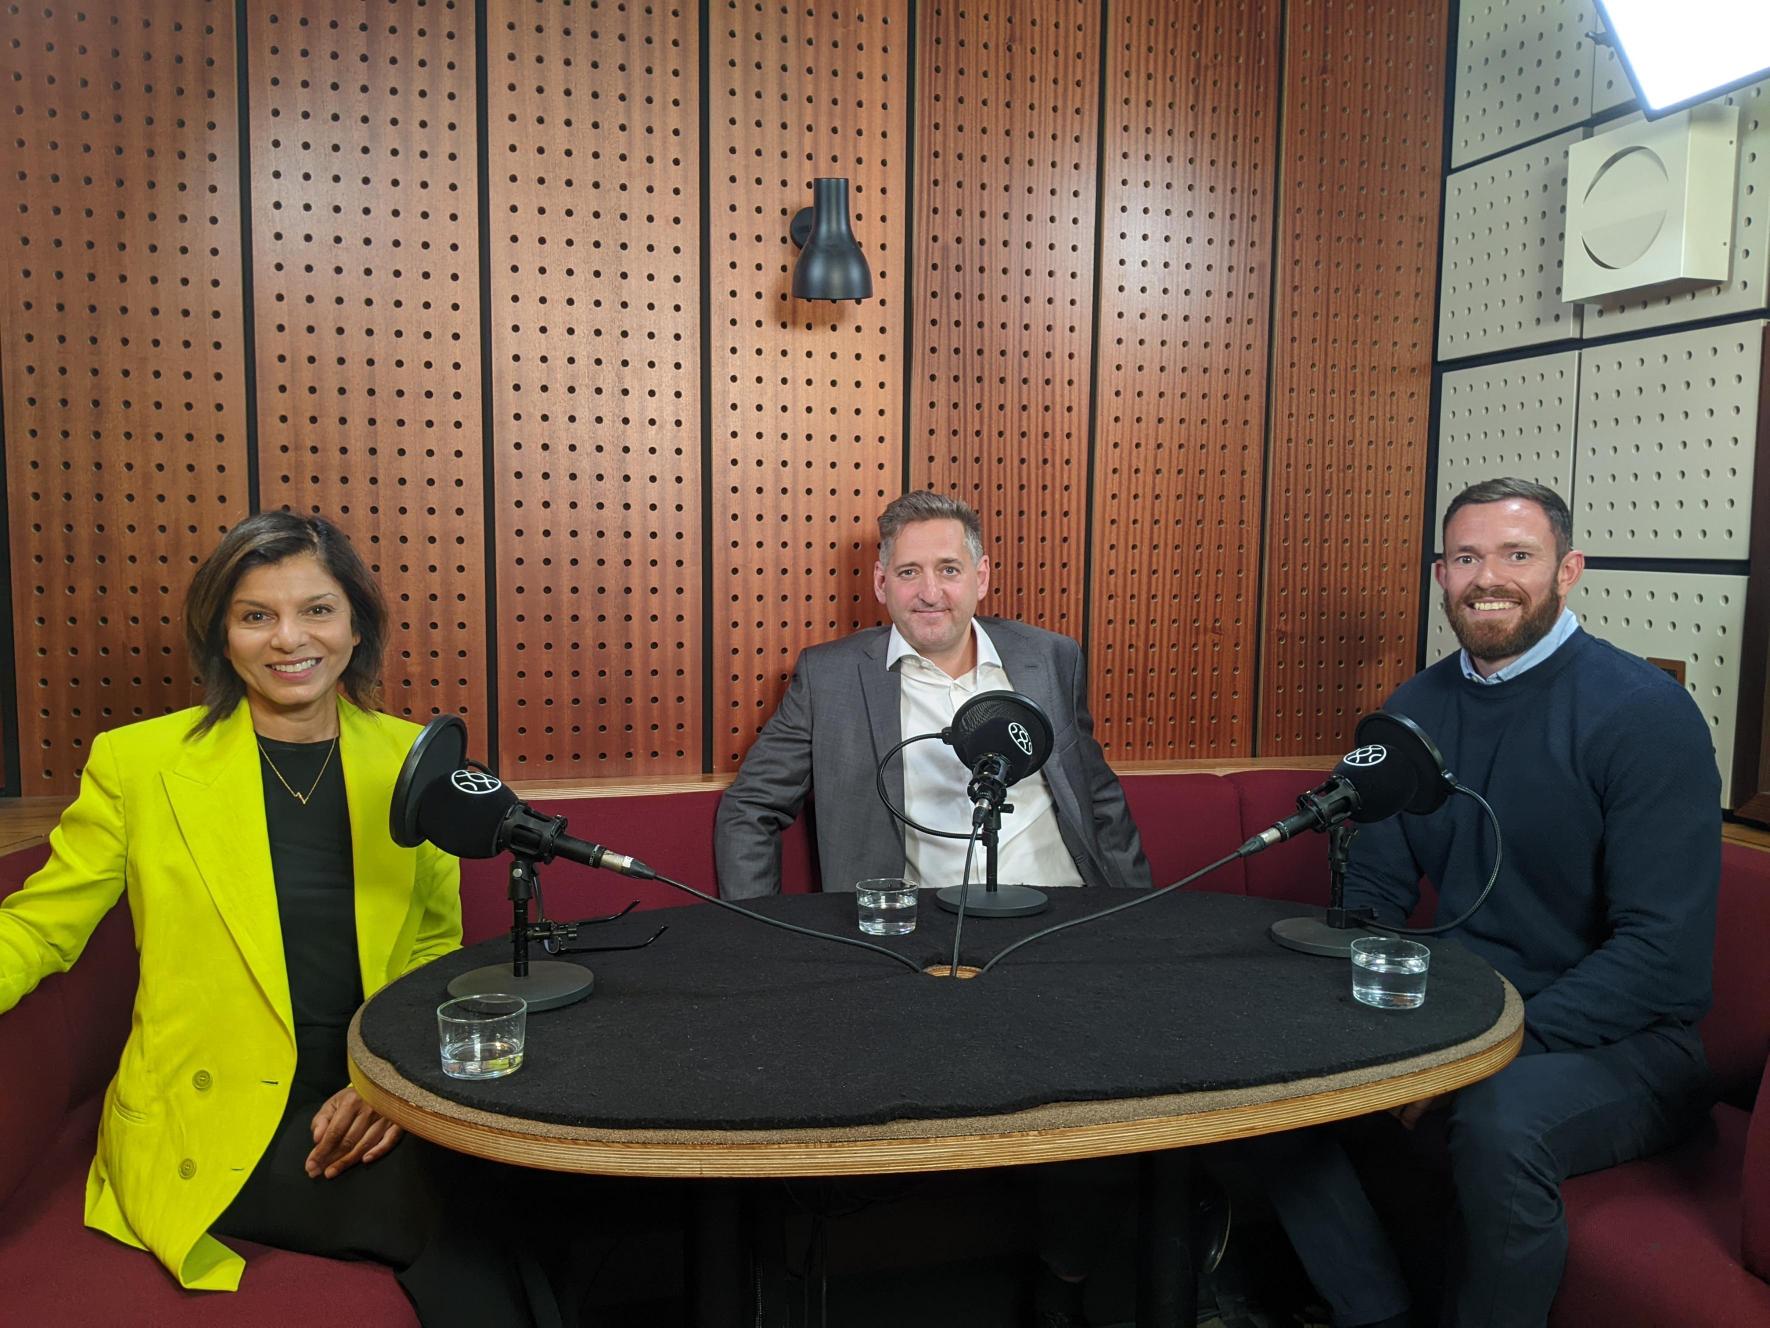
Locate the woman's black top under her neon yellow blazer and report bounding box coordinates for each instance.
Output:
[258,737,363,1101]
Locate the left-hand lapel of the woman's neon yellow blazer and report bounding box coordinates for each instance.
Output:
[161,701,294,1031]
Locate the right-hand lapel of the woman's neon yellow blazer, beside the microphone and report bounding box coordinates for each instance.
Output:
[338,699,418,995]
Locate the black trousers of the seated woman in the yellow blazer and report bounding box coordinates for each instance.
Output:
[212,1101,559,1328]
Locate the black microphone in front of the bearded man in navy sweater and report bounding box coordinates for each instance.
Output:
[1235,710,1455,857]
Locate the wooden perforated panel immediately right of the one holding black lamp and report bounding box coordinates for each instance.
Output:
[910,0,1101,636]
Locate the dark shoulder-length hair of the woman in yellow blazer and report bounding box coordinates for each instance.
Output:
[184,512,388,738]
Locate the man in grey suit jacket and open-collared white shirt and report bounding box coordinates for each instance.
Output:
[713,490,1151,899]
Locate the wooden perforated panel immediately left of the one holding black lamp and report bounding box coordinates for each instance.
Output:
[487,0,703,779]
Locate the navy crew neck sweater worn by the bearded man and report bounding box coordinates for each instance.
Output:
[1347,630,1720,1050]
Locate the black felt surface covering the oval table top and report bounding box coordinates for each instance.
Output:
[361,889,1503,1130]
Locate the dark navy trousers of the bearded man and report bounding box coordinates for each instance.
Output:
[1243,1029,1710,1328]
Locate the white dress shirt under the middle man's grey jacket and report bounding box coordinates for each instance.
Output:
[885,618,1081,887]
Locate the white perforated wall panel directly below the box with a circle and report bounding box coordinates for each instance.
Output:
[1574,322,1765,560]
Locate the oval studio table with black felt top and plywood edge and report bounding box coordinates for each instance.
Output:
[350,891,1524,1324]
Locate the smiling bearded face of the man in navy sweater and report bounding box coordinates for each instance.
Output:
[1434,498,1586,678]
